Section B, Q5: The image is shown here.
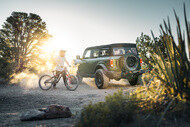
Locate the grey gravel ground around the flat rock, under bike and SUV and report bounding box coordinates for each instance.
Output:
[0,79,135,127]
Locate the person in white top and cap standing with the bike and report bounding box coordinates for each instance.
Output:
[53,50,71,88]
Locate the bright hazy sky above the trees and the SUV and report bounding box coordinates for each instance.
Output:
[0,0,190,60]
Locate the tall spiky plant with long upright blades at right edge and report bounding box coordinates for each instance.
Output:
[151,4,190,101]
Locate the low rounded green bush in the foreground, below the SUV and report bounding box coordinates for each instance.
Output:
[76,90,138,127]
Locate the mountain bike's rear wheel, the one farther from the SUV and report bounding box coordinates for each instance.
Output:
[39,75,54,90]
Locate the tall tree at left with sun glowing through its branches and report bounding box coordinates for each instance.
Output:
[0,12,51,71]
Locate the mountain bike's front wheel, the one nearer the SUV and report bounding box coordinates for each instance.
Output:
[64,75,79,91]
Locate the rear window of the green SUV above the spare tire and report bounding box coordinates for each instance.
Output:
[113,47,137,56]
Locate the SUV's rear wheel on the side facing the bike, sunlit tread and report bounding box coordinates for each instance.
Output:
[95,69,109,89]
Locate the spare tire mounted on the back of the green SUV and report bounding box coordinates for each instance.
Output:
[124,53,140,71]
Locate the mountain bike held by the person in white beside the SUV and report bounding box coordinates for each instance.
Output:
[39,68,79,91]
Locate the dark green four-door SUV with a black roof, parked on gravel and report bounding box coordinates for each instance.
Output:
[76,43,142,89]
